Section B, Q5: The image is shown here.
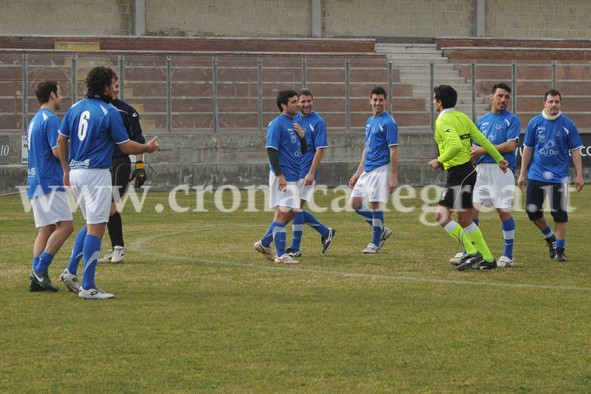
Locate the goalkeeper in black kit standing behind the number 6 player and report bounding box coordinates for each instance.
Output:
[99,76,146,263]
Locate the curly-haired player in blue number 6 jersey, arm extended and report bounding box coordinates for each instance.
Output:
[57,66,159,299]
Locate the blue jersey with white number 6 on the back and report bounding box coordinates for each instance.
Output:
[59,98,129,168]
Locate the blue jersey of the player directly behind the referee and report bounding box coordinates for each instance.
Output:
[476,111,521,172]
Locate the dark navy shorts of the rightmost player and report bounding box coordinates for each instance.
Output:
[525,179,568,223]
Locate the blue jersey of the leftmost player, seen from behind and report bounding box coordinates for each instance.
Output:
[27,108,66,198]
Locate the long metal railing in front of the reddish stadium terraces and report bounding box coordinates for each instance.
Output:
[0,51,591,133]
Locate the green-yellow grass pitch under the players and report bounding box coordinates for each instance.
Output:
[0,189,591,393]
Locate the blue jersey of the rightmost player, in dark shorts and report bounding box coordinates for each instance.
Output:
[523,115,583,183]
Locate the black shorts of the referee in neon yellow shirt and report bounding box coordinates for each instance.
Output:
[438,162,476,211]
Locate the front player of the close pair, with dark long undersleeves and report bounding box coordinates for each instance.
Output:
[253,90,307,264]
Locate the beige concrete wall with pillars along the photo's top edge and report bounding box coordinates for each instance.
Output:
[0,0,591,39]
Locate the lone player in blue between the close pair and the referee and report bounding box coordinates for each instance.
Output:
[349,86,398,254]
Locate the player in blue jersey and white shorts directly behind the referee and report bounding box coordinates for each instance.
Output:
[450,83,521,267]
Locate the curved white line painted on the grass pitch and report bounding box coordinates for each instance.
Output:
[128,229,591,291]
